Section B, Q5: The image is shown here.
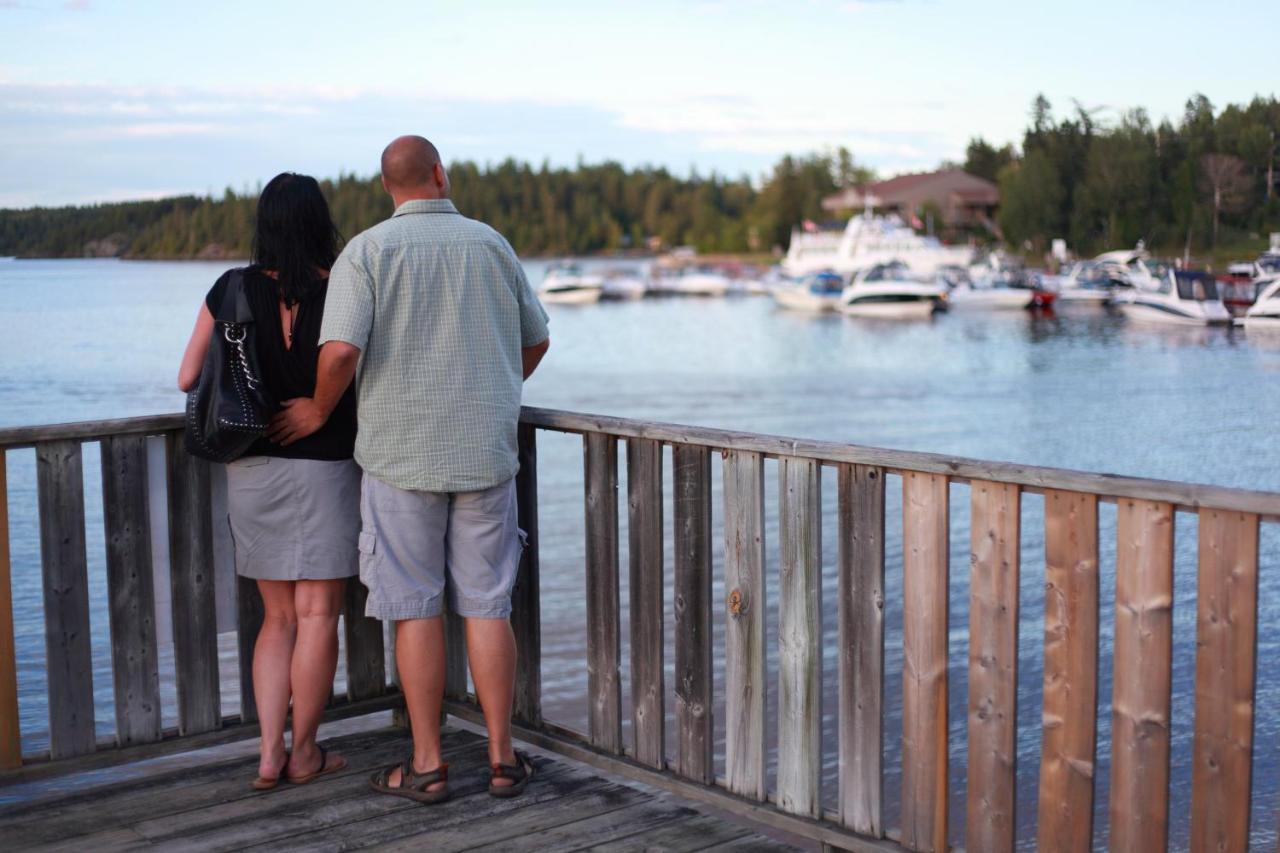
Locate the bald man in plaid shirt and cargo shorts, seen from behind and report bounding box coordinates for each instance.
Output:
[269,136,550,803]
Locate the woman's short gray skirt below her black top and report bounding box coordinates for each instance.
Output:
[227,456,360,580]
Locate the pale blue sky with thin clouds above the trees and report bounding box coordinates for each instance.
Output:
[0,0,1280,207]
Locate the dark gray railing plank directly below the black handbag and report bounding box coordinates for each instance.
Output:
[165,433,221,734]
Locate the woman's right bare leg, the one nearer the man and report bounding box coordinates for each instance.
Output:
[289,579,347,776]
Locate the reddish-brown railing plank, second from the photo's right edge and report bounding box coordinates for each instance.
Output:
[1110,500,1174,853]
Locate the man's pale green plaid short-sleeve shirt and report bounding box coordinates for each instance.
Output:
[320,199,548,492]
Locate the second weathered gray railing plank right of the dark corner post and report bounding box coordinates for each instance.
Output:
[627,438,666,770]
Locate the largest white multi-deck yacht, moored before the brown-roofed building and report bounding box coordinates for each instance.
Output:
[782,213,973,277]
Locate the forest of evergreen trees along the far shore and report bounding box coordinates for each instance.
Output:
[0,95,1280,259]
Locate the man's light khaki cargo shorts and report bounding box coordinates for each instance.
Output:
[360,474,525,621]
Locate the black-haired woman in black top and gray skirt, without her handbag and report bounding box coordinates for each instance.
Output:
[178,173,360,790]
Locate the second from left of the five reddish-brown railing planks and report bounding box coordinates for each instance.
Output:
[965,482,1021,850]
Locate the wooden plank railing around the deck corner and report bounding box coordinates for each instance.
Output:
[0,409,1280,850]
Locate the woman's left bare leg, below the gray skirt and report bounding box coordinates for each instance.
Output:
[253,580,298,779]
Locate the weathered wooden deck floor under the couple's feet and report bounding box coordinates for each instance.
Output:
[0,729,795,853]
